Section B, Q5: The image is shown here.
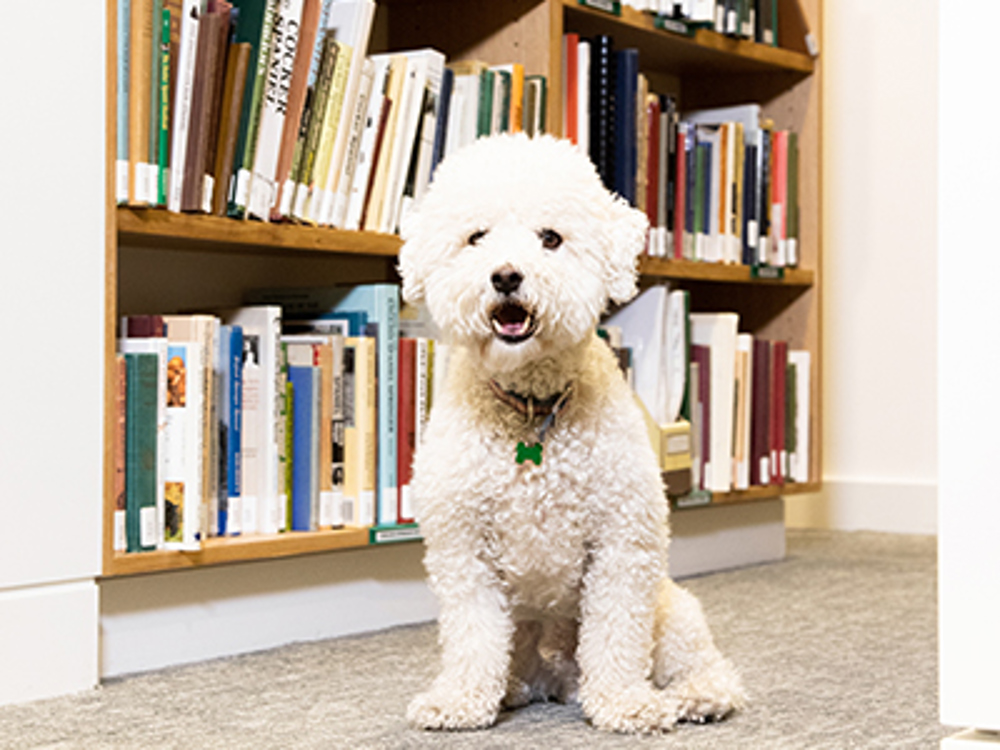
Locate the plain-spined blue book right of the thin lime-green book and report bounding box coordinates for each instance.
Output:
[288,365,321,531]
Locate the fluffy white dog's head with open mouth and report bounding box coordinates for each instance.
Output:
[399,134,647,371]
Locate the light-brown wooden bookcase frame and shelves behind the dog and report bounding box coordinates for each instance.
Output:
[103,0,822,577]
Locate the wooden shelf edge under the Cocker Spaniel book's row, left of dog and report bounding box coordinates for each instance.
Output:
[116,206,402,258]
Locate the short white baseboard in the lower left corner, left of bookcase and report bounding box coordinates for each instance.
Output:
[0,579,98,706]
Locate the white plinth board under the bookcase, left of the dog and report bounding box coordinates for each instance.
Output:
[101,544,438,678]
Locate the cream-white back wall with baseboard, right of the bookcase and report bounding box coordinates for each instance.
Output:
[788,0,938,533]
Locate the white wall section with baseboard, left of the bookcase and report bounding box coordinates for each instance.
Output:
[0,3,105,705]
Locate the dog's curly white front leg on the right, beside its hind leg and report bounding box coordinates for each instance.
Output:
[577,539,679,733]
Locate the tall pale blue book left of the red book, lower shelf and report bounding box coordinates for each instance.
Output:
[248,284,399,526]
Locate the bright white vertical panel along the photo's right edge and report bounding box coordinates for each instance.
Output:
[938,0,1000,736]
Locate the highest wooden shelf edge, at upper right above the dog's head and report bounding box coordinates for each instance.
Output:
[562,0,815,75]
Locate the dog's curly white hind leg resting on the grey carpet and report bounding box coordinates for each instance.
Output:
[653,579,746,722]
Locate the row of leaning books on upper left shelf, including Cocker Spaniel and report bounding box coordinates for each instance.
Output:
[116,0,547,233]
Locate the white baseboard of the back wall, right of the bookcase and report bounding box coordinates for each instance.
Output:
[786,479,937,534]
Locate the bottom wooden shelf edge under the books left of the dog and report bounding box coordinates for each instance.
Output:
[102,528,370,578]
